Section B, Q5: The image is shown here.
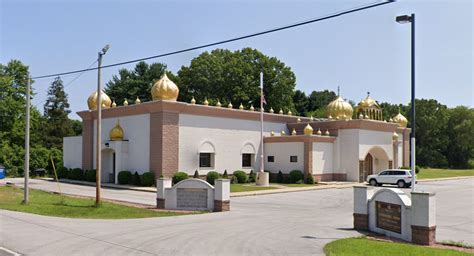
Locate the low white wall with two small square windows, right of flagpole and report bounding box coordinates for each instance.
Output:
[265,142,304,173]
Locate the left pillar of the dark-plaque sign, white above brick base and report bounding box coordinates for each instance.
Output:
[353,186,374,230]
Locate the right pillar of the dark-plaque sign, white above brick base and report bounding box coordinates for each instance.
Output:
[411,192,436,245]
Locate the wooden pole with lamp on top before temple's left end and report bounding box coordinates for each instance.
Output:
[95,45,110,206]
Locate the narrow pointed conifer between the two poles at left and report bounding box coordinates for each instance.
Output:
[44,77,74,149]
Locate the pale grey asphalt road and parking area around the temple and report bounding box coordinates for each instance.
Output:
[0,178,474,255]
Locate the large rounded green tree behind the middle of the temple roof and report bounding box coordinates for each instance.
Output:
[178,48,296,112]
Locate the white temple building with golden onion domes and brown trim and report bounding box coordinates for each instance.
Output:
[63,75,410,183]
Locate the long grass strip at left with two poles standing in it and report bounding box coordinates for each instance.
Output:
[0,186,194,219]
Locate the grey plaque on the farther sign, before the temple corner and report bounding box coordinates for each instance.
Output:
[176,188,207,209]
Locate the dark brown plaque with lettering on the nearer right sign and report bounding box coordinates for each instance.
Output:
[375,201,402,234]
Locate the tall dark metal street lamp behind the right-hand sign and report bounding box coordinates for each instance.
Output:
[395,13,416,191]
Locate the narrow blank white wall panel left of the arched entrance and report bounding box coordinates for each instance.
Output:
[313,142,333,174]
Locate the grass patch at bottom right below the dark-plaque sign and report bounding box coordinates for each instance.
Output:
[324,237,472,256]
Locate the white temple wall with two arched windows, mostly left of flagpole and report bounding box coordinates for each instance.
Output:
[179,114,288,175]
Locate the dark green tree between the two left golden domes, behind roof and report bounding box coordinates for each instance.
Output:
[105,61,178,105]
